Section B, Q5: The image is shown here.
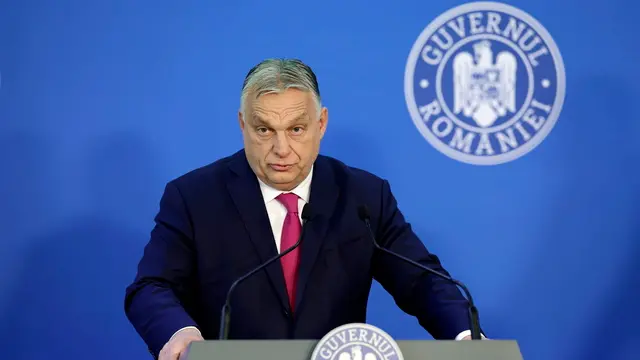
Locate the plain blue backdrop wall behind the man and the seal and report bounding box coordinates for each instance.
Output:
[0,0,640,360]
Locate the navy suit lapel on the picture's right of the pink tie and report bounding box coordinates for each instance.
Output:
[295,156,339,311]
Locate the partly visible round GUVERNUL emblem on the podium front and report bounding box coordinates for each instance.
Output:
[311,323,404,360]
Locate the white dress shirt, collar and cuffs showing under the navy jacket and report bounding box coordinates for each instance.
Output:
[169,167,480,341]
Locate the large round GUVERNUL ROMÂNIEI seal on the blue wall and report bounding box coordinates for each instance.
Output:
[404,2,565,165]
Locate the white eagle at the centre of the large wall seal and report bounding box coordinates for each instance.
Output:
[453,40,517,128]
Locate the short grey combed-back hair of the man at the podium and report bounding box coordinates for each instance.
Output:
[240,59,322,118]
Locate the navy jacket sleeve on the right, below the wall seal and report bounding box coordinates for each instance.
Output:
[372,181,469,340]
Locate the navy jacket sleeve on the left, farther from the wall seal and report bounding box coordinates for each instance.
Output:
[124,183,197,357]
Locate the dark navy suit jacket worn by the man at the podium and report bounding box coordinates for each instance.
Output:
[125,150,469,355]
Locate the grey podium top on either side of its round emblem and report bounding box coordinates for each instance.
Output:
[181,340,522,360]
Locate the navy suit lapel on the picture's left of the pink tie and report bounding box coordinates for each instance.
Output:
[227,151,289,309]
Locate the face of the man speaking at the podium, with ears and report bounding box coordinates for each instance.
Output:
[238,89,328,191]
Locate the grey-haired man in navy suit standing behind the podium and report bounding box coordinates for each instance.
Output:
[125,59,480,360]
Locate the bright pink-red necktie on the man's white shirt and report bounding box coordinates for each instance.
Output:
[277,193,302,312]
